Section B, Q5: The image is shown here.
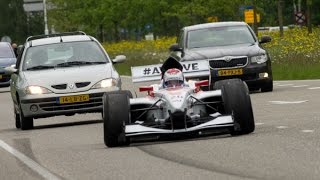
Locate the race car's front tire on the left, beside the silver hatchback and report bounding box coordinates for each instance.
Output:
[103,91,132,147]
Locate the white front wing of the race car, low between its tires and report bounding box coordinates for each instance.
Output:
[125,115,234,137]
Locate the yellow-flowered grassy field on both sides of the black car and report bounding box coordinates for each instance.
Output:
[103,28,320,80]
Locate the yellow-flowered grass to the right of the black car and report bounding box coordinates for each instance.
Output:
[259,27,320,80]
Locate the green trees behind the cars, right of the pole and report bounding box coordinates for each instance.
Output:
[49,0,320,41]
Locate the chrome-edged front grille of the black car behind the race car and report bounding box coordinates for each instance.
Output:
[209,57,248,69]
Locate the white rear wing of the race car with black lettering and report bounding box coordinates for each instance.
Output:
[131,60,210,83]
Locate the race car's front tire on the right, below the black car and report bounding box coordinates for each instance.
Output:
[219,79,255,135]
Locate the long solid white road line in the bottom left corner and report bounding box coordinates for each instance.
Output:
[0,139,60,180]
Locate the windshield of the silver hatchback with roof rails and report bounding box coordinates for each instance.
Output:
[23,41,108,70]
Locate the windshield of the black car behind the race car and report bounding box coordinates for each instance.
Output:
[187,26,255,48]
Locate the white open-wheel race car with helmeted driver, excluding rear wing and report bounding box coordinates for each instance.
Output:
[103,58,255,147]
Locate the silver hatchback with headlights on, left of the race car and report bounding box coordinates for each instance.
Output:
[6,32,126,130]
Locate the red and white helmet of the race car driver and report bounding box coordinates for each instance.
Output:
[163,68,184,88]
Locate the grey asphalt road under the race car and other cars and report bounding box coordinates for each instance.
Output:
[0,78,320,180]
